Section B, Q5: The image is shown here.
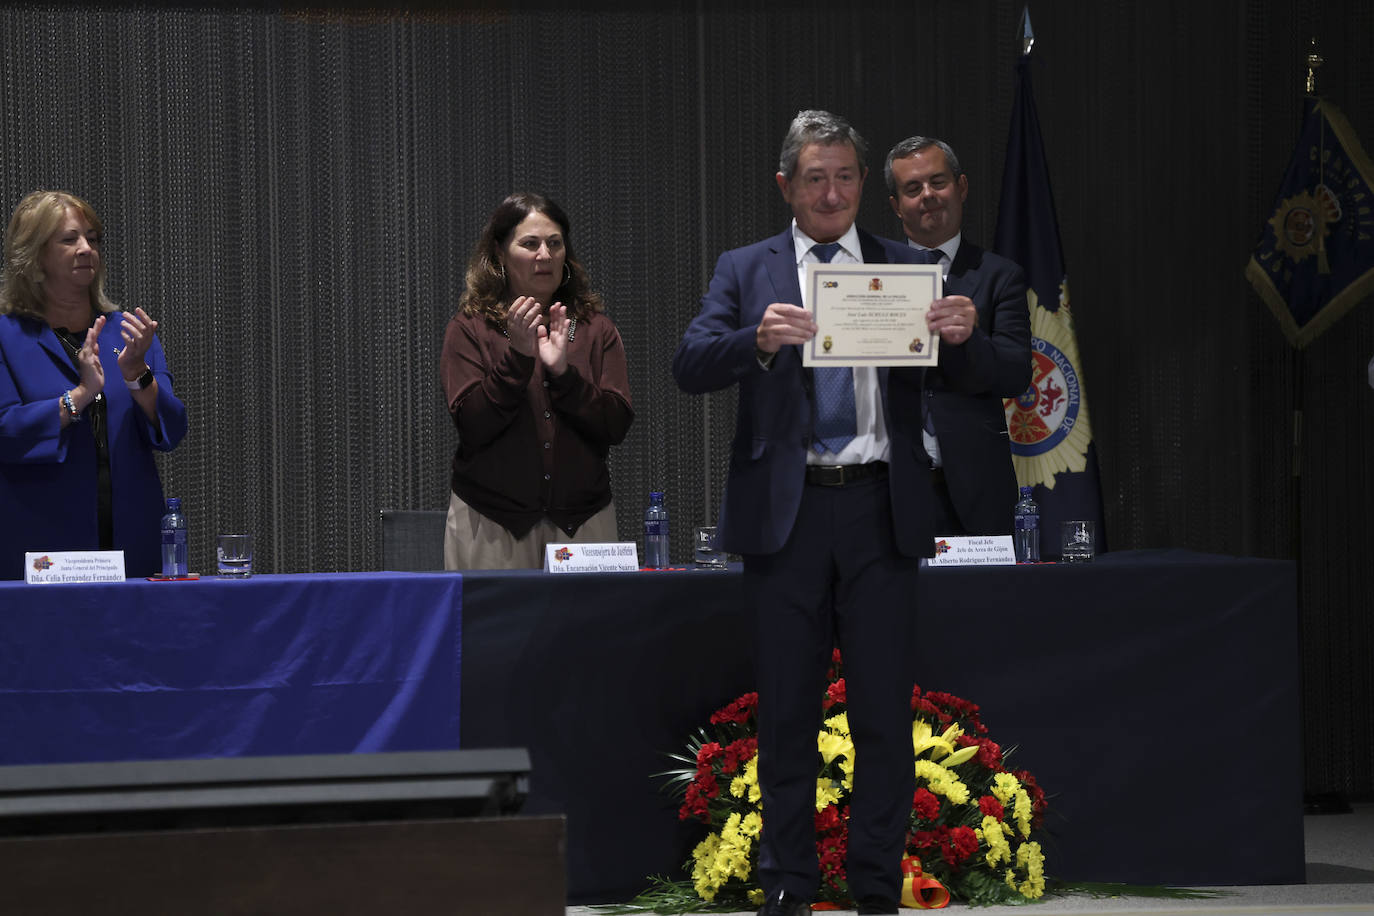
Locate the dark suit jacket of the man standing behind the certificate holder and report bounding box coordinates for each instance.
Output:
[926,239,1031,534]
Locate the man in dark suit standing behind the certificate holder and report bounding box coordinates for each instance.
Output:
[883,137,1031,534]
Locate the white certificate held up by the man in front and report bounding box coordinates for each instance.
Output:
[801,262,944,367]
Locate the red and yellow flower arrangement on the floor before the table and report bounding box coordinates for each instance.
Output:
[666,650,1046,909]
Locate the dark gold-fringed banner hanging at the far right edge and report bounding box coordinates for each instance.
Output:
[1245,96,1374,349]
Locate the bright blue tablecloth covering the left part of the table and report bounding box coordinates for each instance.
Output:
[0,573,463,764]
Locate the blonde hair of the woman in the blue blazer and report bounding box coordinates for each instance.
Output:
[0,191,118,321]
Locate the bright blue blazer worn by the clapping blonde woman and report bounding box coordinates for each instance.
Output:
[0,312,187,578]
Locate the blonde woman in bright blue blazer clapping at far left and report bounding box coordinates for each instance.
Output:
[0,191,187,578]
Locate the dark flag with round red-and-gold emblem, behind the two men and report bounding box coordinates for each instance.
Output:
[993,46,1106,558]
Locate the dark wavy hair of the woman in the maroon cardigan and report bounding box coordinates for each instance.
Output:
[458,191,606,327]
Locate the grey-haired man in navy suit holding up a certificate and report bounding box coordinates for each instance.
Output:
[673,111,977,916]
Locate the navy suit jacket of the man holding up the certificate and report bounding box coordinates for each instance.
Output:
[673,227,962,556]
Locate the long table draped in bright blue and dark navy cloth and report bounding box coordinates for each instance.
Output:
[0,551,1304,902]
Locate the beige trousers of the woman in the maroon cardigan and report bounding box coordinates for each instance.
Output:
[444,492,620,570]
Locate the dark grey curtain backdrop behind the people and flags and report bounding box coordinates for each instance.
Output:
[0,0,1374,797]
